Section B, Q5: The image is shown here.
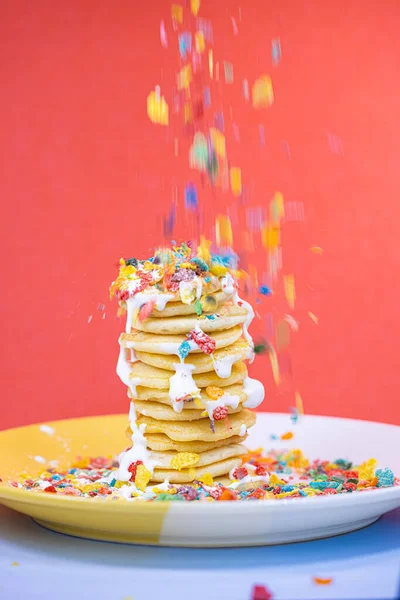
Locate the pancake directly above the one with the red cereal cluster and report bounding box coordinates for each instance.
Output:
[135,305,248,335]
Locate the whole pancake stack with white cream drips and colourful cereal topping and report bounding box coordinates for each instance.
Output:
[110,238,264,492]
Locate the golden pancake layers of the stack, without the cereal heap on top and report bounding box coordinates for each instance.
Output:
[119,278,255,483]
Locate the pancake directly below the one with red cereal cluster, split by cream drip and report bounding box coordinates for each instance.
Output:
[136,338,252,377]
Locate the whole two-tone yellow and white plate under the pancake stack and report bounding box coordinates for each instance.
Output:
[0,413,400,547]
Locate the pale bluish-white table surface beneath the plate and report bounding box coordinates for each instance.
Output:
[0,506,400,600]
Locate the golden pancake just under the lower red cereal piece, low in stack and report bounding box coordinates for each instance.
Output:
[136,409,256,442]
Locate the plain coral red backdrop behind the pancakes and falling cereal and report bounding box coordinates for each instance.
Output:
[0,0,400,427]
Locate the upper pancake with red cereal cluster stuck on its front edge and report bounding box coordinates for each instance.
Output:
[119,325,242,355]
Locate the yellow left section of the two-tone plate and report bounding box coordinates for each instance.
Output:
[0,415,170,544]
